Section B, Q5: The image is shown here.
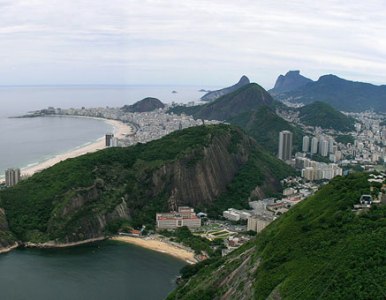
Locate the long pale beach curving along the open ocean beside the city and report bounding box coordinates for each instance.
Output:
[21,118,133,176]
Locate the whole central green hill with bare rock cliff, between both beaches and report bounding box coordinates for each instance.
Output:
[0,125,293,243]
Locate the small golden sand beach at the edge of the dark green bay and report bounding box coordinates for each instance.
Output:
[111,235,197,264]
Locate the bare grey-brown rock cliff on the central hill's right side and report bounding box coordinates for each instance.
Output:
[152,135,251,209]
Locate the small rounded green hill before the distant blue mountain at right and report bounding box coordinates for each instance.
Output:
[299,101,355,131]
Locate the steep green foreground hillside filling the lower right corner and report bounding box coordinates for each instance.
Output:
[168,173,386,300]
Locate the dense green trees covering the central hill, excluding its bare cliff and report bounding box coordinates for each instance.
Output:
[0,125,291,242]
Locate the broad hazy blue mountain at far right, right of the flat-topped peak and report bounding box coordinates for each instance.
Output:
[275,75,386,112]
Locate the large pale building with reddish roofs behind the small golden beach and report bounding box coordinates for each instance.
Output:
[156,206,201,229]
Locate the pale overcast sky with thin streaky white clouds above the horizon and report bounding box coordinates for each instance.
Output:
[0,0,386,89]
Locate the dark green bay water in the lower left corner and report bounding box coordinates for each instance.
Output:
[0,241,185,300]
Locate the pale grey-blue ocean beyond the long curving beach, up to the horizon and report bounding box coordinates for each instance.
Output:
[0,86,211,179]
